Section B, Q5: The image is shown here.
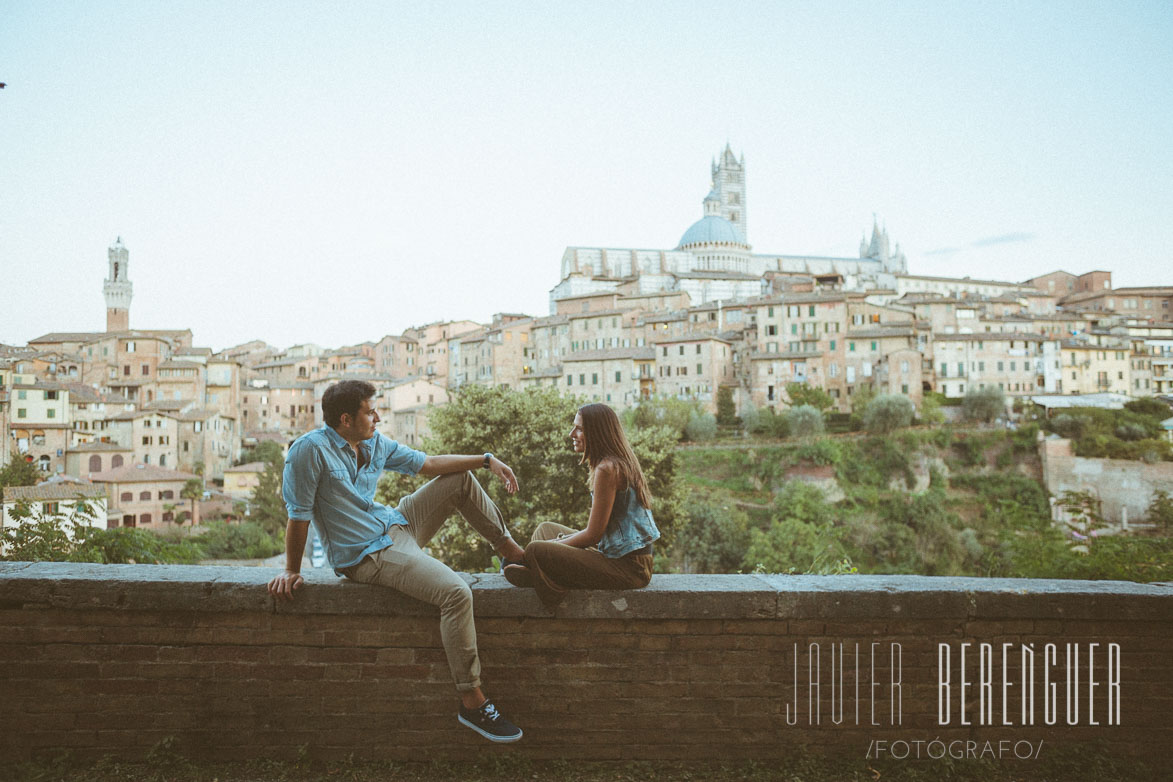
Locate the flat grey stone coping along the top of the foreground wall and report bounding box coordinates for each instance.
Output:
[0,562,1173,621]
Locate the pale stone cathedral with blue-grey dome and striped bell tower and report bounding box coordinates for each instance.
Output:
[550,144,908,313]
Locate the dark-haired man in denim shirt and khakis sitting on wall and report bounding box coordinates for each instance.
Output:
[269,380,524,742]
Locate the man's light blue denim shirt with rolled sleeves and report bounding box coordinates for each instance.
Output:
[282,424,427,576]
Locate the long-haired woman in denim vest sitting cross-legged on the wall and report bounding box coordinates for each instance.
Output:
[504,404,659,607]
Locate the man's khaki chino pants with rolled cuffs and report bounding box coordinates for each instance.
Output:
[343,472,509,692]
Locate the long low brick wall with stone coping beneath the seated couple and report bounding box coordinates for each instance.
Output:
[0,563,1173,762]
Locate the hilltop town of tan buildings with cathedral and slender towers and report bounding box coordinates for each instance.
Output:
[0,147,1173,528]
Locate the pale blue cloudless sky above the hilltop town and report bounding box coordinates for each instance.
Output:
[0,0,1173,348]
